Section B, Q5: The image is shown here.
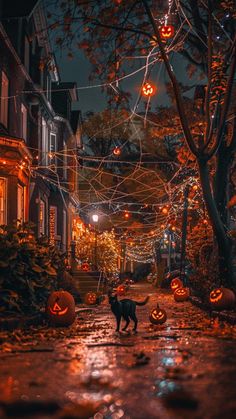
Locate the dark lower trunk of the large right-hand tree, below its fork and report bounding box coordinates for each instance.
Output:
[198,159,236,287]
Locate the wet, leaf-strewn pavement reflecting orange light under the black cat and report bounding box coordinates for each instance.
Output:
[0,284,236,419]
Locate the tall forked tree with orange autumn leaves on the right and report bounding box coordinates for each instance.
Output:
[47,0,236,286]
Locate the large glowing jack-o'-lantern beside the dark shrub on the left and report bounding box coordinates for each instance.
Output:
[46,291,75,326]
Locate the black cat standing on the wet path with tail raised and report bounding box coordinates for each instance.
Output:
[109,294,149,332]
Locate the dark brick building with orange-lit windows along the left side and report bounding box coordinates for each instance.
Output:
[0,0,81,250]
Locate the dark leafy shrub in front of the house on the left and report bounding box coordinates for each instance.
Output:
[0,224,65,314]
